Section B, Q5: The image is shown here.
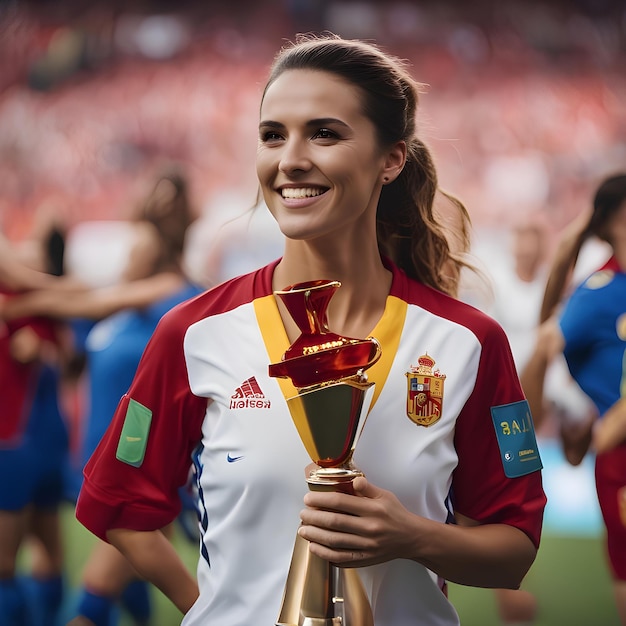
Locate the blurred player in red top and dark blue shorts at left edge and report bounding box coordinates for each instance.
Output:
[0,224,68,626]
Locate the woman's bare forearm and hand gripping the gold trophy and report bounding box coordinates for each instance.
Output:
[298,478,537,589]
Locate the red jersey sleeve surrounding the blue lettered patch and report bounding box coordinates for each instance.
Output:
[452,324,546,547]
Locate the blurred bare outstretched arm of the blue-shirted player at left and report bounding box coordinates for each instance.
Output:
[2,272,184,320]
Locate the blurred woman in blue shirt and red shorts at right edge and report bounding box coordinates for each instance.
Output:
[522,174,626,624]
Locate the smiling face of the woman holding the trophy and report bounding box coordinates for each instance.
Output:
[257,70,393,240]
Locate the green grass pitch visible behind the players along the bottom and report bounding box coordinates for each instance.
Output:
[46,505,619,626]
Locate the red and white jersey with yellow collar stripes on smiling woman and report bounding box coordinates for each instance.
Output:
[77,256,545,626]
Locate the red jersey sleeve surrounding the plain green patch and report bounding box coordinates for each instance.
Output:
[76,310,207,541]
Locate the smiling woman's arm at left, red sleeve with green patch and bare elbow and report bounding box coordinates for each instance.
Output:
[76,310,207,612]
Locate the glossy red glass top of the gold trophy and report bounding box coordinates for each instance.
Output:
[269,280,381,388]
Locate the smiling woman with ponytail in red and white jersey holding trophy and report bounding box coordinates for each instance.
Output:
[77,36,545,626]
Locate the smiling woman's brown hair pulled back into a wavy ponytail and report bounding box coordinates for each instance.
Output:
[264,34,470,295]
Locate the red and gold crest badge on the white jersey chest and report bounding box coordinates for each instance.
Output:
[406,353,446,426]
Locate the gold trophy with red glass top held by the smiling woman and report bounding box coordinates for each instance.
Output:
[269,280,381,626]
